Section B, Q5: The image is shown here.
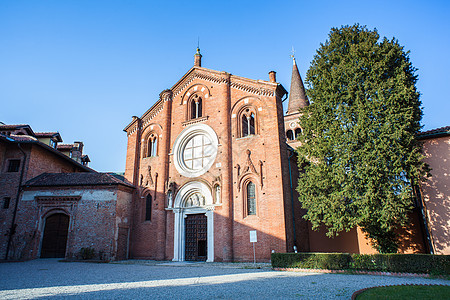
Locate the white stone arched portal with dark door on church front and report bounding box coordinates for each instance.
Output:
[173,181,214,262]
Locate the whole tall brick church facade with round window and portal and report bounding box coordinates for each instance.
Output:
[124,51,308,261]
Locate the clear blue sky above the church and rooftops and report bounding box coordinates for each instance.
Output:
[0,0,450,172]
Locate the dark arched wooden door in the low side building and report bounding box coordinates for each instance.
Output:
[41,213,70,258]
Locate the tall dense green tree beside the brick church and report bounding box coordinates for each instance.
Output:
[297,24,426,253]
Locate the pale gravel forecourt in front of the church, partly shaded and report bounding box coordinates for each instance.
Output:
[0,259,450,299]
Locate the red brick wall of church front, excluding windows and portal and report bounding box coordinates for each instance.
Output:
[126,69,292,261]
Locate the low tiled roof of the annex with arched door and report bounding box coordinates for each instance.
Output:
[25,173,134,188]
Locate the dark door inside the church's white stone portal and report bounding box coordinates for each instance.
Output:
[184,214,208,261]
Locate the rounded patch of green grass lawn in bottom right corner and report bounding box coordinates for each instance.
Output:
[356,285,450,300]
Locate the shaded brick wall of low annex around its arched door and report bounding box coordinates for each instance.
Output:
[10,186,132,260]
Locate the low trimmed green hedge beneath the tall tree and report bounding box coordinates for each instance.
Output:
[272,253,450,275]
